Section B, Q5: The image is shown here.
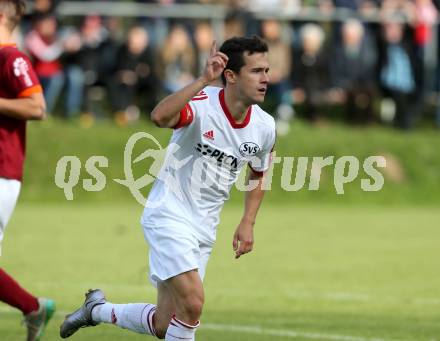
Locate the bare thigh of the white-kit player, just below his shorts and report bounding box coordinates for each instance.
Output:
[166,270,205,310]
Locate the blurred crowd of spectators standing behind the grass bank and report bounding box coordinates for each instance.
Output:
[17,0,440,129]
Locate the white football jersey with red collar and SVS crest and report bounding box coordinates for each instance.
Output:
[141,87,275,243]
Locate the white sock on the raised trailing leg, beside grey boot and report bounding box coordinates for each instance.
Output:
[92,302,156,336]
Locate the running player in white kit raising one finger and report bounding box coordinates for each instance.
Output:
[60,36,275,341]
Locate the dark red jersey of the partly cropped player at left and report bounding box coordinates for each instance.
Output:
[0,45,42,181]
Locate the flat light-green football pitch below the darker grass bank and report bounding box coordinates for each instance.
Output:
[0,202,440,341]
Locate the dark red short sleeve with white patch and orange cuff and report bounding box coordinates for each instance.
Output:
[6,53,42,98]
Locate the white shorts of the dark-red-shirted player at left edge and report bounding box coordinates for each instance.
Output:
[0,178,21,256]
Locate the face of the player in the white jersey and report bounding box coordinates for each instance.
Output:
[237,52,269,104]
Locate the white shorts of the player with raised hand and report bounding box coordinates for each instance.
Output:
[143,223,214,288]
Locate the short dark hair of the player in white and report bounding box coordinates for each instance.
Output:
[220,35,269,84]
